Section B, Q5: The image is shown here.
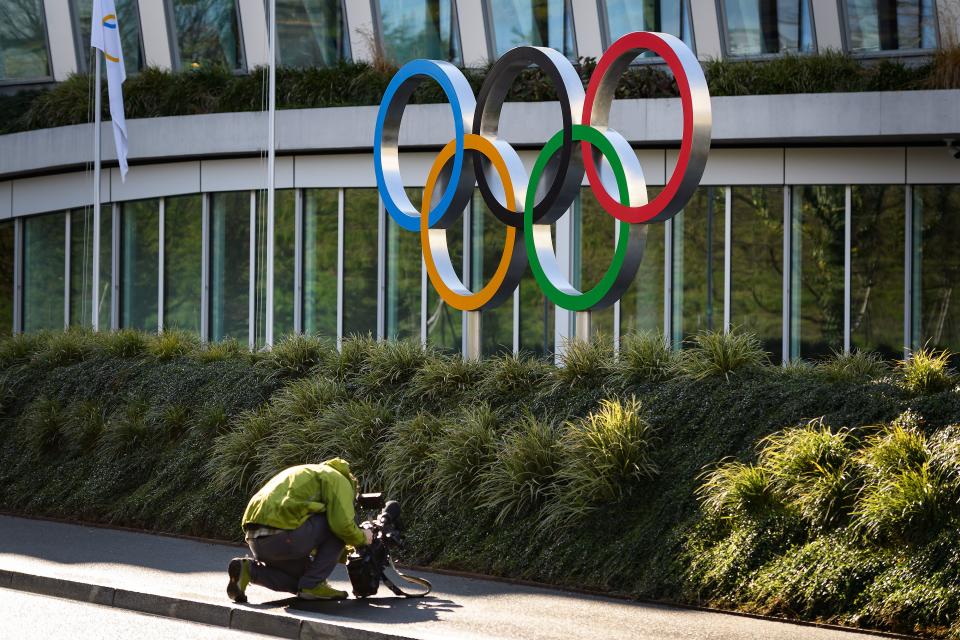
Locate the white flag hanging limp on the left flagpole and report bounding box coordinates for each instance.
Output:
[90,0,128,181]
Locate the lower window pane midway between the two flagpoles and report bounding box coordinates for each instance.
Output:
[163,195,203,333]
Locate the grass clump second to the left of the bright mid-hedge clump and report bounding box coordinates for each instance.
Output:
[426,404,500,507]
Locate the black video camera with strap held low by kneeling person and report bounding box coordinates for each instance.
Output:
[347,493,433,598]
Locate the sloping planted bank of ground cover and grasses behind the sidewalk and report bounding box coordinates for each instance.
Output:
[0,331,960,638]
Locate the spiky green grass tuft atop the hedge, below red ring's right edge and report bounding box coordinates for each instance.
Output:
[674,331,769,380]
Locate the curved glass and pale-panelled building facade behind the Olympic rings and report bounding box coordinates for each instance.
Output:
[0,0,960,360]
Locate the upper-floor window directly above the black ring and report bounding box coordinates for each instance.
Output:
[487,0,577,58]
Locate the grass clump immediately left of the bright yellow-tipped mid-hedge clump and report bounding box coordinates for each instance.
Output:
[477,414,563,524]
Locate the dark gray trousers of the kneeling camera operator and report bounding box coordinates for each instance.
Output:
[247,513,344,593]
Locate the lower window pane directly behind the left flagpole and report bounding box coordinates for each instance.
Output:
[70,205,113,330]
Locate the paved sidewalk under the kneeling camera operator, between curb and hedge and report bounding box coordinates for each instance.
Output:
[0,516,884,640]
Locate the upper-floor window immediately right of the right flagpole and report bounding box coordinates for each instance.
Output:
[276,0,350,67]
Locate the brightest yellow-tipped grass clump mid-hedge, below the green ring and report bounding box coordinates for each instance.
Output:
[540,397,659,530]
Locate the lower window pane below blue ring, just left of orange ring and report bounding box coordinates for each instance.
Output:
[386,188,423,340]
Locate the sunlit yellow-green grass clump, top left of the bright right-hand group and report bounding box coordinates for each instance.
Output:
[760,420,860,530]
